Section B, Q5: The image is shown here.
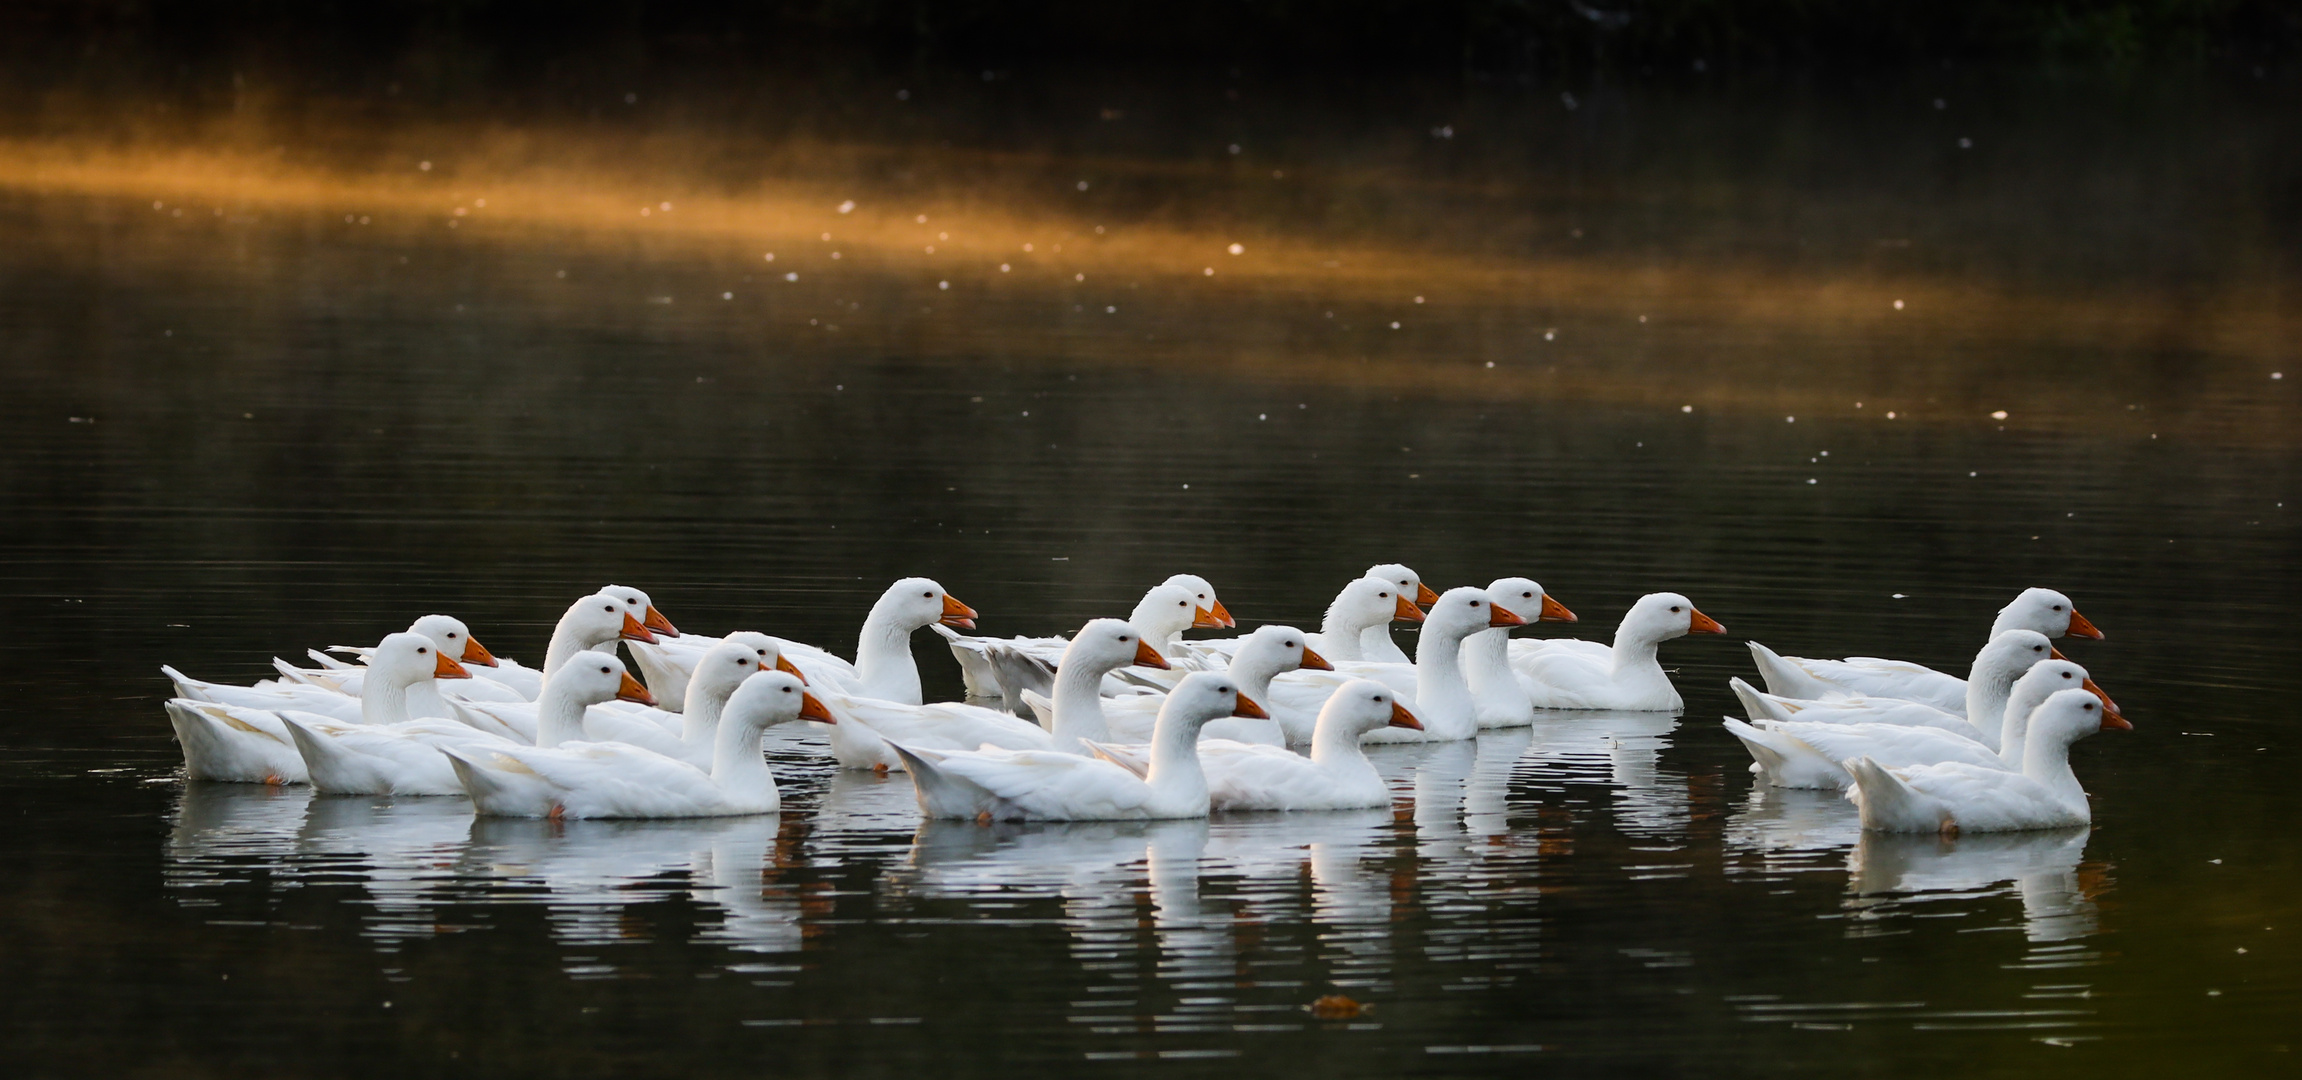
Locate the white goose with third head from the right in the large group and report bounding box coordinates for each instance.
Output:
[1271,587,1526,741]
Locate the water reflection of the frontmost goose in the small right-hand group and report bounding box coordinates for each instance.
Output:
[1846,827,2097,942]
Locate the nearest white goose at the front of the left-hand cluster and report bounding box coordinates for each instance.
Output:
[444,656,831,820]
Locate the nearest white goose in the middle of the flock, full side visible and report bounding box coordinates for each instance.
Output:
[898,672,1261,822]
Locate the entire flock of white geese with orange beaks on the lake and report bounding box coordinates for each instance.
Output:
[161,564,2129,831]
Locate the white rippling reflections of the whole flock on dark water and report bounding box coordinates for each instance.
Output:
[163,712,2106,1057]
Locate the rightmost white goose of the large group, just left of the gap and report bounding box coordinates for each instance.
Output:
[1510,592,1727,712]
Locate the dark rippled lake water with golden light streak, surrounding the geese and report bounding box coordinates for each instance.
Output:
[0,71,2302,1075]
